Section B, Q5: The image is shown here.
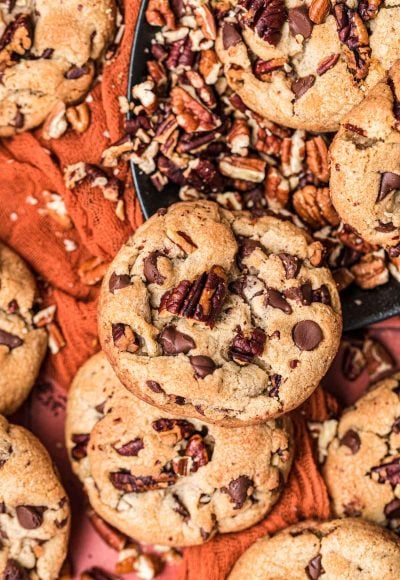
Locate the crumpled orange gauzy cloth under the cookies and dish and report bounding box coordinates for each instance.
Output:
[0,0,334,580]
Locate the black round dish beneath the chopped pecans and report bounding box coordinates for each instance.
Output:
[128,0,400,332]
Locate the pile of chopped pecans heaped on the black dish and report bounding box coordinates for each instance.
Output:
[103,0,400,290]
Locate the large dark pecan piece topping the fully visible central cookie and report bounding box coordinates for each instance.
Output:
[159,266,228,328]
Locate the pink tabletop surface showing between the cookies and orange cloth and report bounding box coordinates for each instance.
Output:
[12,318,400,580]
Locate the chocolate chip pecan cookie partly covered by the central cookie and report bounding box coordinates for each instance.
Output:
[66,353,293,546]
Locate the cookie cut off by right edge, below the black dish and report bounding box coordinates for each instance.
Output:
[324,374,400,532]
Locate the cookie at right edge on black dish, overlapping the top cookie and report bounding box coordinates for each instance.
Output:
[330,61,400,257]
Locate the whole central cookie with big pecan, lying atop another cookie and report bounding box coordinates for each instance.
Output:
[99,201,341,426]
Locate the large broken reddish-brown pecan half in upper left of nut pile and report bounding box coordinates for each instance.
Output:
[171,87,221,133]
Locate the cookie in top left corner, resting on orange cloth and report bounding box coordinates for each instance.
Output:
[0,0,116,137]
